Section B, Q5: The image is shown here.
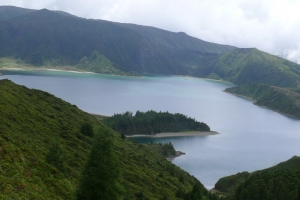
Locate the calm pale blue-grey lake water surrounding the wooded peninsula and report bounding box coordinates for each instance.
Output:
[0,71,300,189]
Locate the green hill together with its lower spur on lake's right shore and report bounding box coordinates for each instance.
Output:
[190,48,300,117]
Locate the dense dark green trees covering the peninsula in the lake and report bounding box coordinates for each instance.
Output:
[103,111,210,135]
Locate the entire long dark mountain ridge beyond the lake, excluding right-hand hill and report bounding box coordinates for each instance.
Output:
[0,7,235,75]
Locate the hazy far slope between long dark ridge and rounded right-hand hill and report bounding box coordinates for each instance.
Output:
[118,23,235,75]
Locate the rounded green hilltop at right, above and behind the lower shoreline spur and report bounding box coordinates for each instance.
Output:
[194,49,300,87]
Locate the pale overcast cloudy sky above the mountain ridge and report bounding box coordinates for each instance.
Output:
[0,0,300,63]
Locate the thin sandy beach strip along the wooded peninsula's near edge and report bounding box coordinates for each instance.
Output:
[126,131,220,138]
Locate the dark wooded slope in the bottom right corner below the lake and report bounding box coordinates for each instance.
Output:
[214,156,300,200]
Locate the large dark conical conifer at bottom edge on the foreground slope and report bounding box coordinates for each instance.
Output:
[76,129,124,200]
